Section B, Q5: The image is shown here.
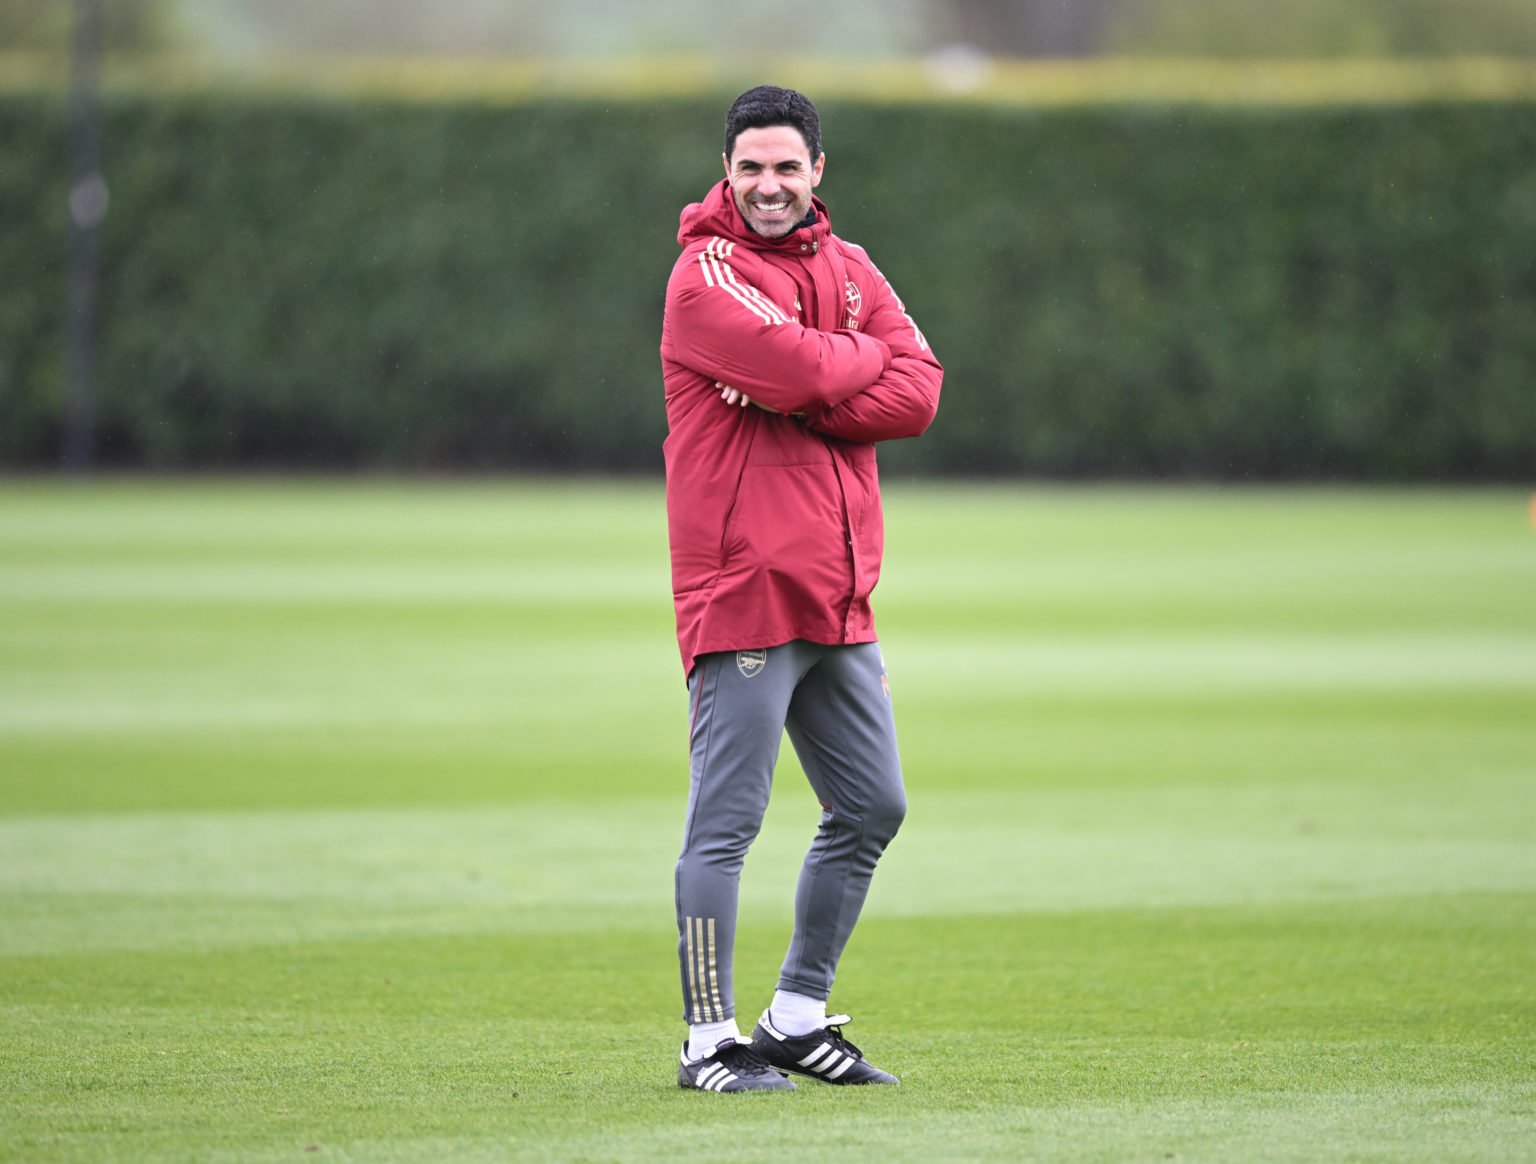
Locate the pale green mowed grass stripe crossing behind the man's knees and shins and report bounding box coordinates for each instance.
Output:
[0,777,1536,954]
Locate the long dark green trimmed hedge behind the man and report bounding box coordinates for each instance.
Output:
[0,94,1536,479]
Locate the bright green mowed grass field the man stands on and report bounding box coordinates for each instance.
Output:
[0,481,1536,1164]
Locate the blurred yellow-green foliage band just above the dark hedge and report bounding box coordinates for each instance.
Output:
[0,52,1536,107]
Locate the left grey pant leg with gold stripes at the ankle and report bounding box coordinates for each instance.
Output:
[676,643,814,1023]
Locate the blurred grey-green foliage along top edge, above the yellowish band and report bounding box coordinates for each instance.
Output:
[87,0,1536,63]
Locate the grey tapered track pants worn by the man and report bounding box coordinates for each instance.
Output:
[677,642,906,1023]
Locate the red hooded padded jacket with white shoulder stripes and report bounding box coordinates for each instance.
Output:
[662,181,943,673]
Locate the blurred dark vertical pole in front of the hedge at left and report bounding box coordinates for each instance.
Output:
[63,0,108,475]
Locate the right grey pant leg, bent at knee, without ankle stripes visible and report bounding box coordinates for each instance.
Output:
[779,643,906,998]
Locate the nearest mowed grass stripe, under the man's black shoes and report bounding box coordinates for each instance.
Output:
[0,895,1536,1159]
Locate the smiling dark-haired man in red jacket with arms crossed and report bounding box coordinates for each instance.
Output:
[660,86,943,1092]
